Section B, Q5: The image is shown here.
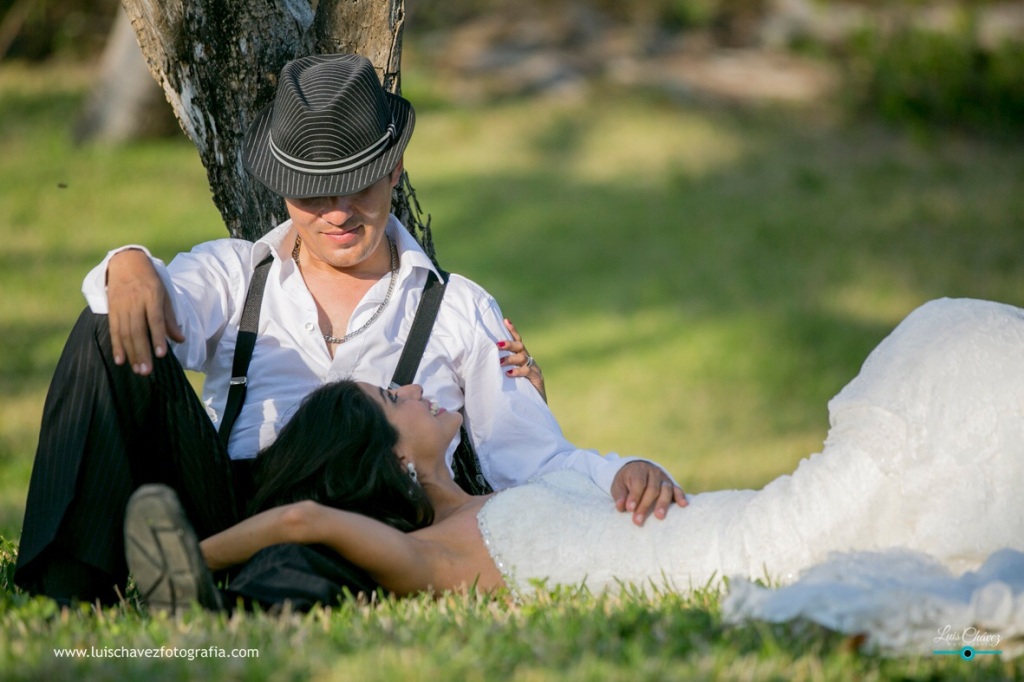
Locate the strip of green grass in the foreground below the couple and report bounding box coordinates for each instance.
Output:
[0,557,1021,682]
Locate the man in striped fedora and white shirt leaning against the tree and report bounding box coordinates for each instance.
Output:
[15,55,684,601]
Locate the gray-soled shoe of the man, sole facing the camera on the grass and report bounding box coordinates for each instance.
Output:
[125,484,224,613]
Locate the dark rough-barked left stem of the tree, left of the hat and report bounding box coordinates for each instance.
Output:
[123,0,313,240]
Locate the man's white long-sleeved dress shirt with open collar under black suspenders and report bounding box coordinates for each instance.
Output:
[82,216,635,491]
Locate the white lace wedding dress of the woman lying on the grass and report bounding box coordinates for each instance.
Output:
[478,299,1024,648]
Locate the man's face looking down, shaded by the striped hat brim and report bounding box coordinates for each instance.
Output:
[285,162,401,270]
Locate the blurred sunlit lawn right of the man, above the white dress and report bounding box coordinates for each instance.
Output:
[409,82,1024,489]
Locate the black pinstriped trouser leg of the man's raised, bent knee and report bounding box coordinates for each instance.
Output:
[14,308,244,601]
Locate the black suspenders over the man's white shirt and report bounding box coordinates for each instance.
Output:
[217,255,493,495]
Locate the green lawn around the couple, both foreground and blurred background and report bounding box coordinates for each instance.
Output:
[0,63,1024,680]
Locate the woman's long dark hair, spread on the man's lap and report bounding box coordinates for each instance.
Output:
[250,381,434,531]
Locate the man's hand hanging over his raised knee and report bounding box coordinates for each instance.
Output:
[106,249,185,375]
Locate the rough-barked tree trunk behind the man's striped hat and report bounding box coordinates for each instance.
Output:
[122,0,429,251]
